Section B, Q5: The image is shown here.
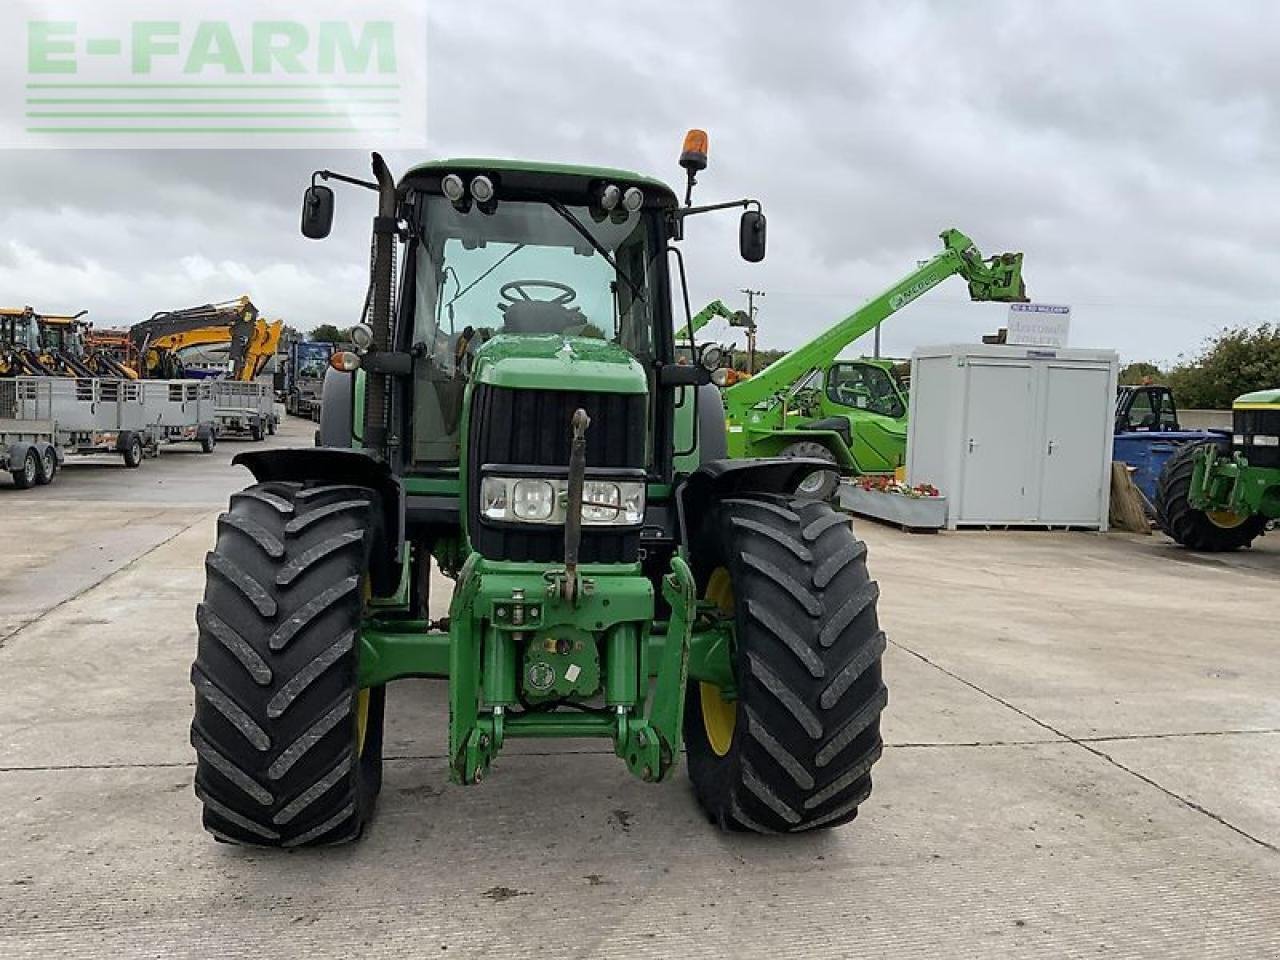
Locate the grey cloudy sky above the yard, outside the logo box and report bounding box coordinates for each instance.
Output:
[0,0,1280,361]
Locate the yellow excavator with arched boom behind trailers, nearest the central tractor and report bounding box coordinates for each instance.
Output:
[129,297,284,381]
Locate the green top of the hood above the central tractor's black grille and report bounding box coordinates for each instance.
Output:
[475,334,649,394]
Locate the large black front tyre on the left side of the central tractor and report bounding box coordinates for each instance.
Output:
[191,483,385,846]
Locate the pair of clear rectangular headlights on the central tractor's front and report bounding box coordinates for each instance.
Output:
[480,476,645,526]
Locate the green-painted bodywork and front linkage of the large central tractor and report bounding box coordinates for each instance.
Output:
[337,160,735,783]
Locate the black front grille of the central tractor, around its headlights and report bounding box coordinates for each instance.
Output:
[467,384,649,563]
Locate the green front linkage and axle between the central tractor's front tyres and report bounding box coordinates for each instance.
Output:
[360,554,701,783]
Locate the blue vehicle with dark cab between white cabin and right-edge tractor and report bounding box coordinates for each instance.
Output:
[1111,384,1224,512]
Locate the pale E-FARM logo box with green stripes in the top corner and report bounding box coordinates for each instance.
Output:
[0,0,426,148]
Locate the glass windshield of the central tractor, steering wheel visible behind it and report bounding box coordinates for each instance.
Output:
[412,196,660,462]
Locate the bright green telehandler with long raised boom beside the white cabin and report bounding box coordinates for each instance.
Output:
[724,229,1027,499]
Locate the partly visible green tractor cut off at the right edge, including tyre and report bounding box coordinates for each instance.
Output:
[1156,390,1280,553]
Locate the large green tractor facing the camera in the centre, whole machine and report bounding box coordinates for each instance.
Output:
[192,134,886,846]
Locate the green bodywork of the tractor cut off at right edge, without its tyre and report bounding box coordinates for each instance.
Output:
[1189,390,1280,520]
